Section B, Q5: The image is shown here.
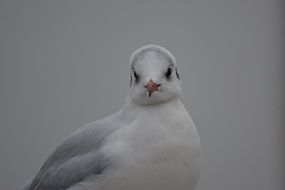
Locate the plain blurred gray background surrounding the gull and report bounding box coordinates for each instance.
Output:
[0,0,284,190]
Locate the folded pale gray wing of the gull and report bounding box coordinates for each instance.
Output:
[24,121,116,190]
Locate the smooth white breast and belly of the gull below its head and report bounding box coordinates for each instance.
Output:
[69,100,200,190]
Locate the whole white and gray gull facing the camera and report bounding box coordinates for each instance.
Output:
[23,44,201,190]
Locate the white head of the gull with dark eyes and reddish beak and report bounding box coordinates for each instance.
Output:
[129,45,182,105]
